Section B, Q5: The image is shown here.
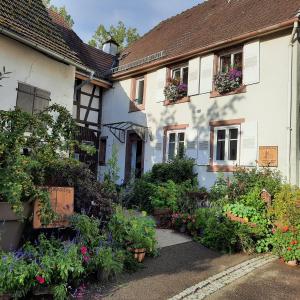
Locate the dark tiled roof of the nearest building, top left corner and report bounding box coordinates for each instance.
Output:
[0,0,82,65]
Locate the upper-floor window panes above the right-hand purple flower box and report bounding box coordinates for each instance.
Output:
[219,50,243,74]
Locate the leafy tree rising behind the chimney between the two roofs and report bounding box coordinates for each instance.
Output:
[89,21,140,50]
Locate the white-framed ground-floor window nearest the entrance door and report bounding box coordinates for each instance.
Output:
[167,131,185,160]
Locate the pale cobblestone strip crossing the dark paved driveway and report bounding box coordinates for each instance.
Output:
[169,255,278,300]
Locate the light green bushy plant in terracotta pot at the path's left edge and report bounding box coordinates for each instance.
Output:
[108,207,156,254]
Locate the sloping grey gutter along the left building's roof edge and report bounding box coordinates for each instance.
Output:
[0,27,94,76]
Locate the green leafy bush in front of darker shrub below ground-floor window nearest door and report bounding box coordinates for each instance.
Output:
[150,180,179,211]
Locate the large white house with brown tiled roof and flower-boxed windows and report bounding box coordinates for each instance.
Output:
[101,0,300,187]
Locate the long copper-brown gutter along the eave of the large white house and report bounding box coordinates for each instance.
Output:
[112,17,298,80]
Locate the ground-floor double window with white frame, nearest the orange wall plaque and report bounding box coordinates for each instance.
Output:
[214,126,240,163]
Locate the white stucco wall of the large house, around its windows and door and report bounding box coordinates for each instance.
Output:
[101,32,299,187]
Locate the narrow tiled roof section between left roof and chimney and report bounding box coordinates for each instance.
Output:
[49,9,115,79]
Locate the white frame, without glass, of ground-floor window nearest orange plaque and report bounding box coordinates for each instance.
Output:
[212,125,241,166]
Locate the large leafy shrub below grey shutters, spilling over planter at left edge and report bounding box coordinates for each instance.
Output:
[0,105,85,224]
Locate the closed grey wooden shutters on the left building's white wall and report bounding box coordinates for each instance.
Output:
[17,82,50,114]
